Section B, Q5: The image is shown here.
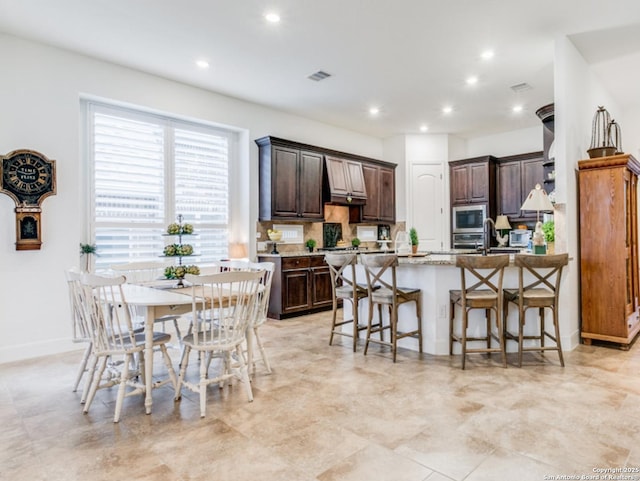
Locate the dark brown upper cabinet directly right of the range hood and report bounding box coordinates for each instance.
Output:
[349,162,396,224]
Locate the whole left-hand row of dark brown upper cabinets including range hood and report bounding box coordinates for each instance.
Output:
[255,136,396,224]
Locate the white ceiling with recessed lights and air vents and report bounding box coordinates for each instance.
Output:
[0,0,640,138]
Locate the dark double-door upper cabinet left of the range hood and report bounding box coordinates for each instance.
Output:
[256,137,324,222]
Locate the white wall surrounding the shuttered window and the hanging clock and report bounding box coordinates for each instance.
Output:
[0,35,383,362]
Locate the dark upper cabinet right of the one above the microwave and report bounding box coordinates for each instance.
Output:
[498,152,544,222]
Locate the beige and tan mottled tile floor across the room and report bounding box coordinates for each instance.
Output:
[0,313,640,481]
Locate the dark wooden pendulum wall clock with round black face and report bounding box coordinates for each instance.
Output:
[0,149,56,250]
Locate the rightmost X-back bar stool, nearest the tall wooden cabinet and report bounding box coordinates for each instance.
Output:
[504,254,569,367]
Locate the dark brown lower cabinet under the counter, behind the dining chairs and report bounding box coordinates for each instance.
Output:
[258,255,332,319]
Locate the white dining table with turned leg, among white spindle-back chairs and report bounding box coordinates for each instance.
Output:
[122,281,191,414]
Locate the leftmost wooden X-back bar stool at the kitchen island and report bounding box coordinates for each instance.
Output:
[324,253,368,352]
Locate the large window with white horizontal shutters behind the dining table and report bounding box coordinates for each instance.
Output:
[86,102,233,269]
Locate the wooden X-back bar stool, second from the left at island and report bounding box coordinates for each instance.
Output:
[360,254,422,362]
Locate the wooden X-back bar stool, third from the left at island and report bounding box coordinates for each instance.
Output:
[449,255,509,369]
